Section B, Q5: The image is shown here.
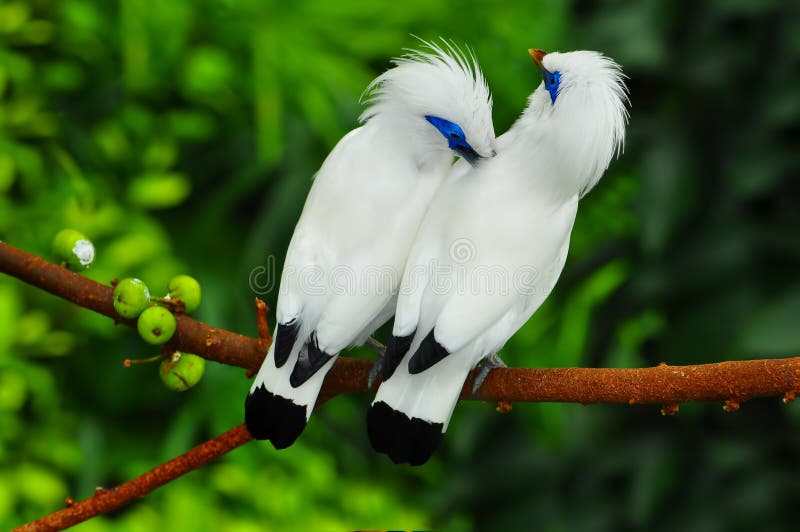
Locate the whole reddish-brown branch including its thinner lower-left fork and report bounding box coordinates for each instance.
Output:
[0,242,800,530]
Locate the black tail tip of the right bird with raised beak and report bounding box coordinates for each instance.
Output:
[367,401,444,466]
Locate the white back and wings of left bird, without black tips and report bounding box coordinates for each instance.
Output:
[277,125,444,353]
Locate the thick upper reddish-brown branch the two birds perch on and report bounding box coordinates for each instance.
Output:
[0,242,800,404]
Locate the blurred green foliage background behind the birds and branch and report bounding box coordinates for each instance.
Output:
[0,0,800,531]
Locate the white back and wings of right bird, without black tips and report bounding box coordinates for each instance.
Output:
[394,159,577,358]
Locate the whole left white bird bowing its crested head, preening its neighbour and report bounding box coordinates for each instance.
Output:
[245,41,495,449]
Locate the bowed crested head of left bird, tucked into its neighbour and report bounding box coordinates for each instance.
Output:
[361,40,496,164]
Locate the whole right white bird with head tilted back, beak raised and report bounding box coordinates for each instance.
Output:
[367,50,628,465]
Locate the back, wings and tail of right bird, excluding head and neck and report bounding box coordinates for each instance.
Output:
[367,150,578,464]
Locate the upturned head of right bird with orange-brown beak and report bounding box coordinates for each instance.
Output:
[528,49,629,195]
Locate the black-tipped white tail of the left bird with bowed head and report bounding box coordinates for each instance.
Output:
[244,325,336,449]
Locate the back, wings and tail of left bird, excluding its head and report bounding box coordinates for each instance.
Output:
[245,121,449,448]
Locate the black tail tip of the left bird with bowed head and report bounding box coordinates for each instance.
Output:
[244,385,306,449]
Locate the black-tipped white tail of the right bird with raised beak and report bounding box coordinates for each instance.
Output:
[367,344,471,465]
